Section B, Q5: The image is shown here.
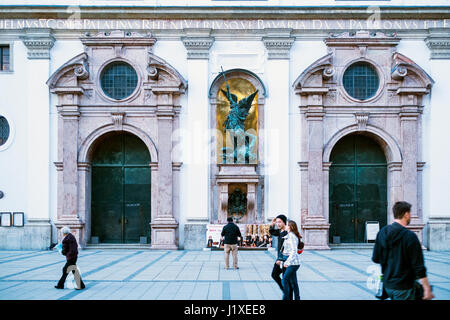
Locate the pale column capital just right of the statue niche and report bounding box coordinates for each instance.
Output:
[262,29,295,60]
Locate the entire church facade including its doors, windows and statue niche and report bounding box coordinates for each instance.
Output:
[0,0,450,250]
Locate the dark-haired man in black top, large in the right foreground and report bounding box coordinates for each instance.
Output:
[372,201,434,300]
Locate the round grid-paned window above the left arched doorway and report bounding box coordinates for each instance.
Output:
[100,61,138,100]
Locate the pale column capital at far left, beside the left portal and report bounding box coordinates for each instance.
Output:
[20,29,55,59]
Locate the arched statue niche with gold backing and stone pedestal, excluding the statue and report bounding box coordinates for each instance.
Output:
[209,69,267,223]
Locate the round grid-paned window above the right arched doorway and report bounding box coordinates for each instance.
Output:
[343,62,380,100]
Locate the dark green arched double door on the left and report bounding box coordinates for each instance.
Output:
[91,131,151,243]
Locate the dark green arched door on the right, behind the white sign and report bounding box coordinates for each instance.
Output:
[329,134,387,243]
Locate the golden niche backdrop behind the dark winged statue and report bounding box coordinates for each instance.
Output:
[216,78,259,163]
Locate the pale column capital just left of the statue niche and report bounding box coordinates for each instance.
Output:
[181,29,214,60]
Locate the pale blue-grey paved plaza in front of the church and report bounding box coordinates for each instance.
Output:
[0,249,450,300]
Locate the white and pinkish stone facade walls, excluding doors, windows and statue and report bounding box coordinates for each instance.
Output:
[0,0,450,250]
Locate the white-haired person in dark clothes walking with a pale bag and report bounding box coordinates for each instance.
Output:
[55,227,85,290]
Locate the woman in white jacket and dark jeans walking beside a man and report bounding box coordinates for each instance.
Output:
[281,220,303,300]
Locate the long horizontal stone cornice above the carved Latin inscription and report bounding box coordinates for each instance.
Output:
[0,4,450,19]
